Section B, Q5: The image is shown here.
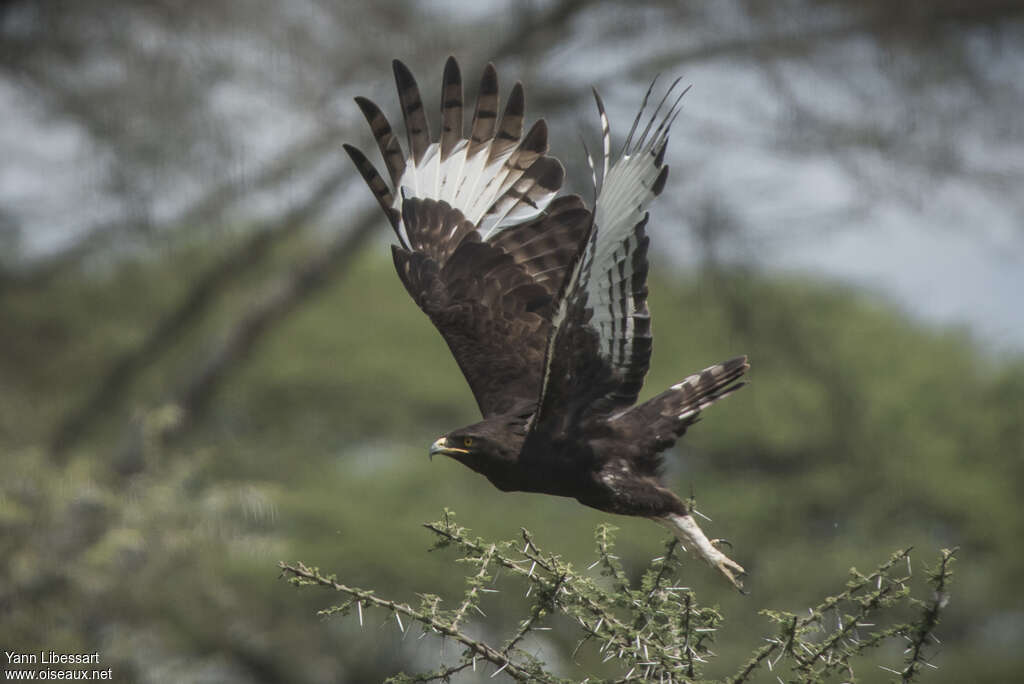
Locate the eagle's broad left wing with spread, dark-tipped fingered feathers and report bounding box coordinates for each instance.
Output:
[345,58,591,417]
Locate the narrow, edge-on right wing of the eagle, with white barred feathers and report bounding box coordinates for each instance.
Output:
[531,81,685,430]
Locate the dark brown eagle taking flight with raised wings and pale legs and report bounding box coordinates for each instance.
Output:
[345,57,749,589]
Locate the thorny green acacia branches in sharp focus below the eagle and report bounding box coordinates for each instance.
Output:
[281,511,951,684]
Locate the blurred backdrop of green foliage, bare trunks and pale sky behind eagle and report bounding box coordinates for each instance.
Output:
[0,0,1024,682]
